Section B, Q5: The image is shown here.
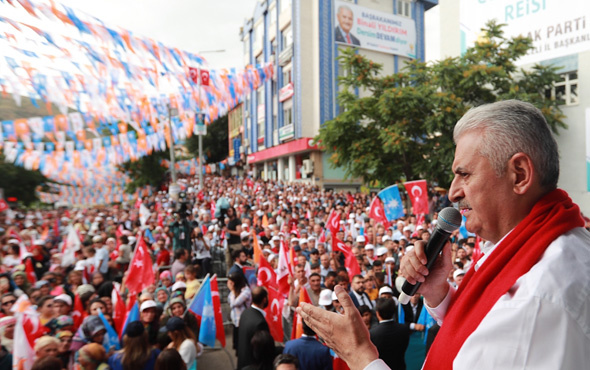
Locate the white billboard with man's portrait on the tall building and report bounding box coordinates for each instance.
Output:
[334,0,416,58]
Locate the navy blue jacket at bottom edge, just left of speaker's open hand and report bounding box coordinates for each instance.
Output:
[283,337,332,370]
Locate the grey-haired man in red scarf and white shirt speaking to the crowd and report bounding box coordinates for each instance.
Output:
[300,100,590,370]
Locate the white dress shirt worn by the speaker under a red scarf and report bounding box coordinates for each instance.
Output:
[365,227,590,370]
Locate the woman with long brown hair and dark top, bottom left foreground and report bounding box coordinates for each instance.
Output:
[109,321,160,370]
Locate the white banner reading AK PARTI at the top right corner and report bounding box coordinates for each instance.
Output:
[460,0,590,65]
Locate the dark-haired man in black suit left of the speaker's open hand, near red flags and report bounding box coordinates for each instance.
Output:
[238,286,270,370]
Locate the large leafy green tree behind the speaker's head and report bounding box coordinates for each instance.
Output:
[317,21,565,186]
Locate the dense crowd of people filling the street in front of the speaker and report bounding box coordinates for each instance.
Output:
[0,171,475,369]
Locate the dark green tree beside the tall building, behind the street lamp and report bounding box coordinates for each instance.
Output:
[185,115,229,163]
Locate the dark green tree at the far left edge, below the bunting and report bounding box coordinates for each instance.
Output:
[0,155,51,206]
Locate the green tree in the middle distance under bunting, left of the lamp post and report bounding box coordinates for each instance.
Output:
[119,150,170,193]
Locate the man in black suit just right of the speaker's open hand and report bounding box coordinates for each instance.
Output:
[370,298,410,370]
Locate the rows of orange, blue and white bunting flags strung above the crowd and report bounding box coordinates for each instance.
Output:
[0,0,274,202]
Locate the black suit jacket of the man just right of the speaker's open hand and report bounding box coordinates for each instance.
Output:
[370,321,410,370]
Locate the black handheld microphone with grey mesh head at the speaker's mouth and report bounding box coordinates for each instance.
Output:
[396,207,461,304]
